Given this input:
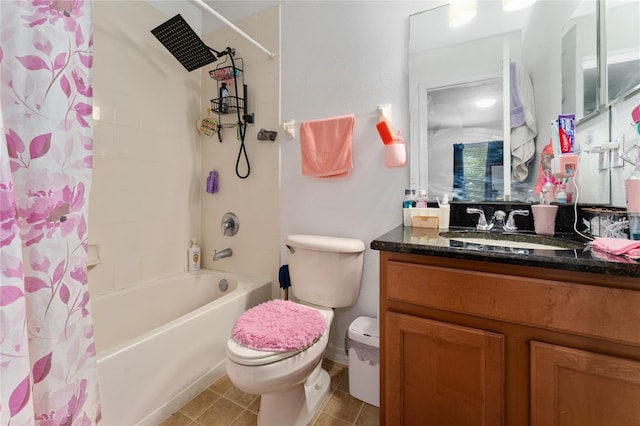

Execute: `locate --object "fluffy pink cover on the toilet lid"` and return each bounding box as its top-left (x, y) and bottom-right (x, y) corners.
top-left (231, 299), bottom-right (327, 352)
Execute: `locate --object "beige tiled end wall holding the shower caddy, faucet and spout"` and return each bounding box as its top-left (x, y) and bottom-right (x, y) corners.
top-left (200, 7), bottom-right (286, 288)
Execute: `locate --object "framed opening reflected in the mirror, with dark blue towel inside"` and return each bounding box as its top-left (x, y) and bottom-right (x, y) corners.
top-left (426, 78), bottom-right (504, 201)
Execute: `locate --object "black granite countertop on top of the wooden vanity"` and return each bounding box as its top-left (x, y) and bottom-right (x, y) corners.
top-left (371, 225), bottom-right (640, 278)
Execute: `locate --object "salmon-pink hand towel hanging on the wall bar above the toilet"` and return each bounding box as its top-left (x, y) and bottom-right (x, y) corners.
top-left (300, 115), bottom-right (355, 177)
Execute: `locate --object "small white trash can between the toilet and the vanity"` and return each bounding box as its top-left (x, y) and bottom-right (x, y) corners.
top-left (345, 317), bottom-right (380, 407)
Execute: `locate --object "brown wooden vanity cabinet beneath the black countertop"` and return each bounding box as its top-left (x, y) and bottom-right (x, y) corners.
top-left (380, 251), bottom-right (640, 426)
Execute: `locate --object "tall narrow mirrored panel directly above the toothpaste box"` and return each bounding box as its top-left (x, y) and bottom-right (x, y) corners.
top-left (561, 0), bottom-right (600, 120)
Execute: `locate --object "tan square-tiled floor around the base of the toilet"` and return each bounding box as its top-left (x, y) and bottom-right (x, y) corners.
top-left (161, 360), bottom-right (380, 426)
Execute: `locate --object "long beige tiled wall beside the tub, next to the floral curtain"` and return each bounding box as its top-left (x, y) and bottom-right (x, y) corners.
top-left (89, 1), bottom-right (201, 296)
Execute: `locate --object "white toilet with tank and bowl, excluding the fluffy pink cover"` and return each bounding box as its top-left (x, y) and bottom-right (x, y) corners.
top-left (226, 235), bottom-right (365, 426)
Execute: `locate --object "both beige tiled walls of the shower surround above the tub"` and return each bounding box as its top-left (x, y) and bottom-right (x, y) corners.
top-left (89, 1), bottom-right (279, 297)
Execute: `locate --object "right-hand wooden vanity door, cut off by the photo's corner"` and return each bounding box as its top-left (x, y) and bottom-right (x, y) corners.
top-left (531, 342), bottom-right (640, 426)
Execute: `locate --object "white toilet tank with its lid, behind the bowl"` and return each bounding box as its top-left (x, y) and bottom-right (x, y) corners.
top-left (285, 235), bottom-right (365, 308)
